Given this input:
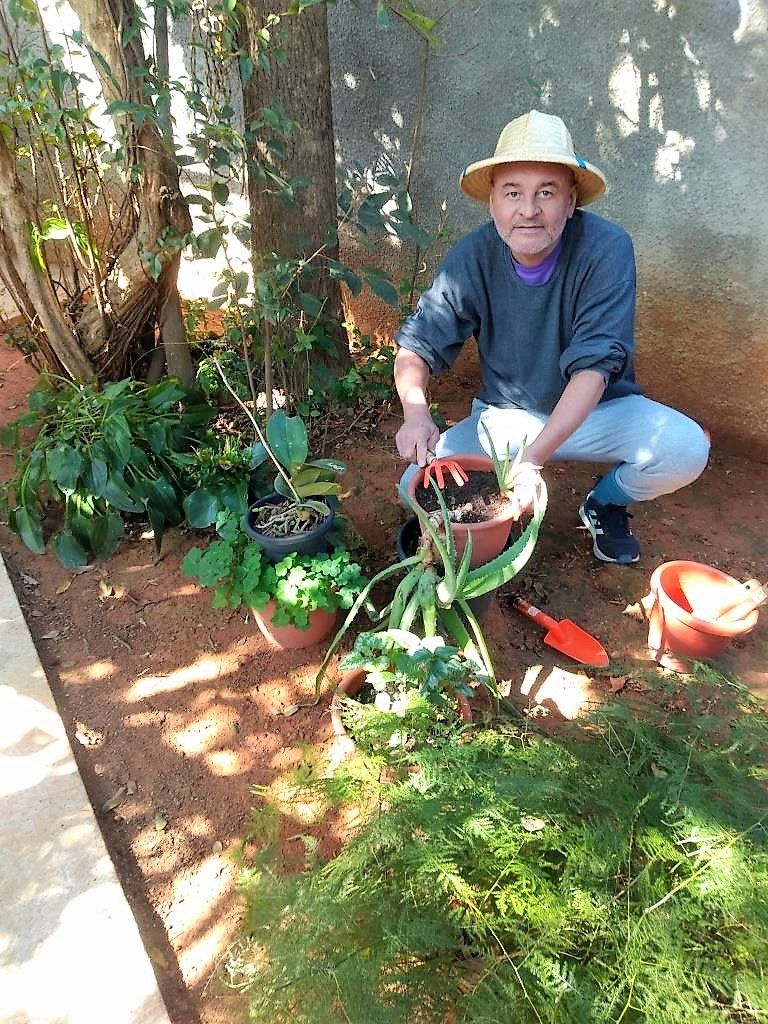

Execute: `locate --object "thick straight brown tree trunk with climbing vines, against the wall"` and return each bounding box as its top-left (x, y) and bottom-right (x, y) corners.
top-left (243, 0), bottom-right (349, 365)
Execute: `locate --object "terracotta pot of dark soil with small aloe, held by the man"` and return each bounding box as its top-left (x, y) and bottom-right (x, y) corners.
top-left (408, 428), bottom-right (539, 568)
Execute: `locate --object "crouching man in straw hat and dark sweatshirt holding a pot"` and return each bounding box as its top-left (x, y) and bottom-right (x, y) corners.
top-left (394, 111), bottom-right (709, 563)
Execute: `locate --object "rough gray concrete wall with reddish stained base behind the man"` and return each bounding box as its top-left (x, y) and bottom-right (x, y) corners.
top-left (330, 0), bottom-right (768, 461)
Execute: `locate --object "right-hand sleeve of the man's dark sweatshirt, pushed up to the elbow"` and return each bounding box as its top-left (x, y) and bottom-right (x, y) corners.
top-left (560, 231), bottom-right (636, 382)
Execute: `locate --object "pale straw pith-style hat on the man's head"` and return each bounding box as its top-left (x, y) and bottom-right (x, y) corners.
top-left (459, 111), bottom-right (606, 206)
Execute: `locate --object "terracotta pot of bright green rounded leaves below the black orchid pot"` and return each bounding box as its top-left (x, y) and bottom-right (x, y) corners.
top-left (181, 517), bottom-right (366, 648)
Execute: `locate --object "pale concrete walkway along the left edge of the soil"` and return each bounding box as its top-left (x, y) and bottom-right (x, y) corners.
top-left (0, 559), bottom-right (169, 1024)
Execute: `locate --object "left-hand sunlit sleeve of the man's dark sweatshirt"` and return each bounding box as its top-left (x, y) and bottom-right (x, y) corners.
top-left (395, 247), bottom-right (479, 374)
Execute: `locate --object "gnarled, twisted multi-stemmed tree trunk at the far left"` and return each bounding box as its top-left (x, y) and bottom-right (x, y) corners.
top-left (0, 0), bottom-right (194, 383)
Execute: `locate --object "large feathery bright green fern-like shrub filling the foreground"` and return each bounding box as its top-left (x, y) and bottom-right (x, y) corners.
top-left (229, 671), bottom-right (768, 1024)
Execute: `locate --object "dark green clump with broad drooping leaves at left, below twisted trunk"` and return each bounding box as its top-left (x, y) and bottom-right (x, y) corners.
top-left (1, 375), bottom-right (213, 566)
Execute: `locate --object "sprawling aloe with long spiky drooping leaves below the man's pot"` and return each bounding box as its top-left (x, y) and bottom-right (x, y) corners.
top-left (315, 476), bottom-right (547, 698)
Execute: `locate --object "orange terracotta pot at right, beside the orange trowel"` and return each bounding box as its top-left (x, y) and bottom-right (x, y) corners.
top-left (648, 561), bottom-right (758, 672)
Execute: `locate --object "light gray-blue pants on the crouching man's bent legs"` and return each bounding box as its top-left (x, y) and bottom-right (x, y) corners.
top-left (402, 394), bottom-right (710, 502)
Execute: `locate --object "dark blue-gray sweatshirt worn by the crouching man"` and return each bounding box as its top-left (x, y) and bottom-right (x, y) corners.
top-left (395, 210), bottom-right (642, 415)
